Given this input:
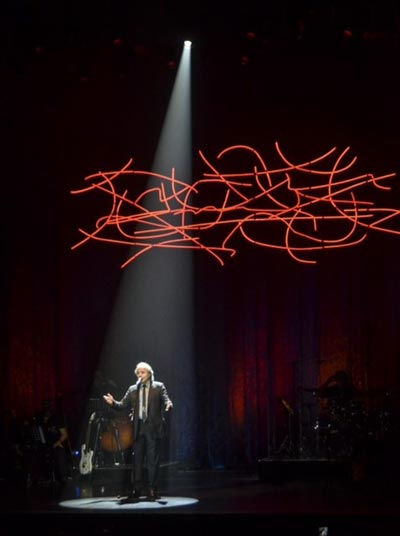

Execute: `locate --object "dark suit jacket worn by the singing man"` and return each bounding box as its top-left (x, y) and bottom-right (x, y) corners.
top-left (113, 381), bottom-right (171, 439)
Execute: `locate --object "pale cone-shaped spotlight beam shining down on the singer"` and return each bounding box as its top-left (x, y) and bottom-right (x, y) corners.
top-left (83, 35), bottom-right (197, 486)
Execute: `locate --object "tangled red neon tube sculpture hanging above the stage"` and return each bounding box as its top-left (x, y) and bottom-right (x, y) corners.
top-left (71, 143), bottom-right (400, 267)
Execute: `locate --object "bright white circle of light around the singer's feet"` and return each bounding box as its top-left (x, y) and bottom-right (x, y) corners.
top-left (59, 497), bottom-right (199, 511)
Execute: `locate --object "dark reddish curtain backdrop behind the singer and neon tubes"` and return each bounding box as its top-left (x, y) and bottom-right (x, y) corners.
top-left (1, 31), bottom-right (400, 467)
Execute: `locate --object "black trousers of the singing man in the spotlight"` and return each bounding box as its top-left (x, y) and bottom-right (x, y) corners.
top-left (132, 422), bottom-right (161, 489)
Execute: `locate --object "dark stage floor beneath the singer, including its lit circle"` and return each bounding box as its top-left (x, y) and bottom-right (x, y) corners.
top-left (0, 460), bottom-right (400, 536)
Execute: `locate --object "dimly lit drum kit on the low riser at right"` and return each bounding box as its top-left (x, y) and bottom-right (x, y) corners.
top-left (277, 385), bottom-right (391, 459)
